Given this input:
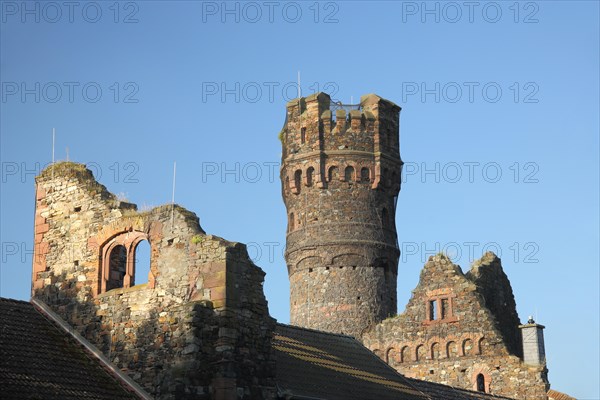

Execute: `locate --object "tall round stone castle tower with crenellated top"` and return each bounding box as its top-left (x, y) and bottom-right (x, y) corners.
top-left (280, 93), bottom-right (402, 337)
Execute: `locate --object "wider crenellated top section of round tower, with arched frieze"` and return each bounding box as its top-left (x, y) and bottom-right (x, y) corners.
top-left (281, 93), bottom-right (402, 193)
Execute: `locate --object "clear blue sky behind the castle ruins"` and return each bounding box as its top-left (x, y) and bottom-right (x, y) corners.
top-left (0, 1), bottom-right (600, 399)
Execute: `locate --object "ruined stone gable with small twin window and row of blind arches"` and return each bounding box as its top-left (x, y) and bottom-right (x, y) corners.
top-left (363, 253), bottom-right (549, 400)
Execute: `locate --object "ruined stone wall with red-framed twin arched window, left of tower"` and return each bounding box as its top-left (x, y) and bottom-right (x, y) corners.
top-left (32, 163), bottom-right (274, 399)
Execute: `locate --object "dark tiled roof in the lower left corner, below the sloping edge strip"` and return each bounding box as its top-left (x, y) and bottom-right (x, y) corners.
top-left (0, 298), bottom-right (137, 400)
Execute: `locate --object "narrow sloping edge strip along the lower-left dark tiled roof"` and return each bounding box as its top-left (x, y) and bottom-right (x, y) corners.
top-left (31, 299), bottom-right (154, 400)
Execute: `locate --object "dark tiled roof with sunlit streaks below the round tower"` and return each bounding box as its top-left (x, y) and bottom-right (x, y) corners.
top-left (273, 324), bottom-right (502, 400)
